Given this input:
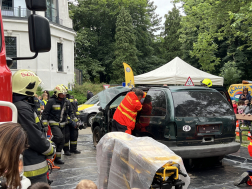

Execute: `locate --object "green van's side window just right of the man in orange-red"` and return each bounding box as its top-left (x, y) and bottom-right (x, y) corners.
top-left (141, 91), bottom-right (166, 116)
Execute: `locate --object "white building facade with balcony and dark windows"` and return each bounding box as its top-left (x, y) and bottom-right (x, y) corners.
top-left (1, 0), bottom-right (76, 90)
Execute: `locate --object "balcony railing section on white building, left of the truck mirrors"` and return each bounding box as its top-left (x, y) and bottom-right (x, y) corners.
top-left (1, 7), bottom-right (31, 18)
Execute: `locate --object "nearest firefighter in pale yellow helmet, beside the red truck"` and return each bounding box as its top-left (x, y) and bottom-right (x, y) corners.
top-left (12, 70), bottom-right (55, 184)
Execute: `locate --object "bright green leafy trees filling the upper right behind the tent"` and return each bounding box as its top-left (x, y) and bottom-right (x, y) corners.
top-left (174, 0), bottom-right (252, 82)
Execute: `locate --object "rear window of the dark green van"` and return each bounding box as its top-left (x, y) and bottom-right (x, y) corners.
top-left (172, 91), bottom-right (234, 117)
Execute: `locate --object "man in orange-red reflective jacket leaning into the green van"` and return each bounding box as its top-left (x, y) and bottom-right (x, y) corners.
top-left (112, 89), bottom-right (146, 134)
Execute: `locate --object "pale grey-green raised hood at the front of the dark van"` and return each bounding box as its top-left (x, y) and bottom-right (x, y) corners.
top-left (98, 86), bottom-right (130, 109)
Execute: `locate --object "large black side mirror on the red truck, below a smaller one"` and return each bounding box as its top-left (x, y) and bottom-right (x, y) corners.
top-left (28, 14), bottom-right (51, 53)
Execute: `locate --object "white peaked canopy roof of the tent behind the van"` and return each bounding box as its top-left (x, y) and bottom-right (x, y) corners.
top-left (134, 57), bottom-right (224, 85)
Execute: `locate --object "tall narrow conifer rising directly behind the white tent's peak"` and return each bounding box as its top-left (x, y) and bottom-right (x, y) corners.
top-left (163, 5), bottom-right (182, 62)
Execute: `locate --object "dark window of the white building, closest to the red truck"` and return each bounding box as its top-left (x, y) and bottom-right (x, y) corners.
top-left (5, 36), bottom-right (17, 69)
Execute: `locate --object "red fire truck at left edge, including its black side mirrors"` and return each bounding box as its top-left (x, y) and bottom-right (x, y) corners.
top-left (0, 0), bottom-right (51, 122)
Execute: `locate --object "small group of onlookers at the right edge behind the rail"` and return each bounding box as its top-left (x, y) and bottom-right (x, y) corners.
top-left (232, 88), bottom-right (252, 127)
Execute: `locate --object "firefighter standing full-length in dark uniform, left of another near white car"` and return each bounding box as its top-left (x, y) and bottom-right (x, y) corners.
top-left (42, 85), bottom-right (78, 164)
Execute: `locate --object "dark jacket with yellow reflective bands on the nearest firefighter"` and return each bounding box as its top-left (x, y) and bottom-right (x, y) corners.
top-left (14, 101), bottom-right (54, 177)
